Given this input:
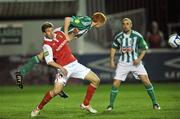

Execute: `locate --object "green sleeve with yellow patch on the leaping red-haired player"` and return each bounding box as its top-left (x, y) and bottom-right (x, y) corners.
top-left (70, 16), bottom-right (92, 27)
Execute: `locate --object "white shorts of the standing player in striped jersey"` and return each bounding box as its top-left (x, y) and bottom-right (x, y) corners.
top-left (114, 62), bottom-right (147, 81)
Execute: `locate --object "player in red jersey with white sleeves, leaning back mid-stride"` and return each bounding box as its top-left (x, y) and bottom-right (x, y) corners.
top-left (31, 19), bottom-right (106, 117)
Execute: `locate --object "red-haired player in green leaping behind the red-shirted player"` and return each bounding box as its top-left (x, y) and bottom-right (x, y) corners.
top-left (15, 12), bottom-right (107, 93)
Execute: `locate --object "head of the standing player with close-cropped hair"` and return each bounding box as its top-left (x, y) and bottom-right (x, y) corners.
top-left (121, 18), bottom-right (132, 33)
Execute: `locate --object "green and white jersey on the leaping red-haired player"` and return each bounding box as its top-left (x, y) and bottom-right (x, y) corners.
top-left (61, 16), bottom-right (92, 37)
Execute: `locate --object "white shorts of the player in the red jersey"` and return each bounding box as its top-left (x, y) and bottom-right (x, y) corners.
top-left (55, 60), bottom-right (91, 86)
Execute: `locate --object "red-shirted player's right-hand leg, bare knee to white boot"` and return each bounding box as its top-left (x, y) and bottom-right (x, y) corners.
top-left (81, 71), bottom-right (100, 113)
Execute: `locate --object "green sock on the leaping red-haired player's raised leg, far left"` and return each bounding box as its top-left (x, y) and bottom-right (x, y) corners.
top-left (18, 56), bottom-right (40, 76)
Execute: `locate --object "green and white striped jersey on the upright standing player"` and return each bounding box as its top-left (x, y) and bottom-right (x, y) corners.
top-left (112, 30), bottom-right (148, 63)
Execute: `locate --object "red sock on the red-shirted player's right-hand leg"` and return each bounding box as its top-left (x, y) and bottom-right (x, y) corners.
top-left (83, 84), bottom-right (96, 106)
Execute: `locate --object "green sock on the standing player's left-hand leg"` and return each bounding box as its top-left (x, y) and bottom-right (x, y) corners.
top-left (110, 86), bottom-right (118, 107)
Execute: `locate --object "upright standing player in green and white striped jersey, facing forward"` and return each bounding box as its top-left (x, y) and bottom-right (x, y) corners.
top-left (107, 18), bottom-right (160, 111)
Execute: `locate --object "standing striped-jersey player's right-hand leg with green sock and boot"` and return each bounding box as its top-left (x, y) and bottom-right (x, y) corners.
top-left (139, 75), bottom-right (160, 110)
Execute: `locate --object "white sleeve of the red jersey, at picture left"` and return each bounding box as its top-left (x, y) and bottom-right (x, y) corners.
top-left (43, 45), bottom-right (54, 64)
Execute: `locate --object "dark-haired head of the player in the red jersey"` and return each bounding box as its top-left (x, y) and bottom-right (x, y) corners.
top-left (41, 22), bottom-right (54, 39)
